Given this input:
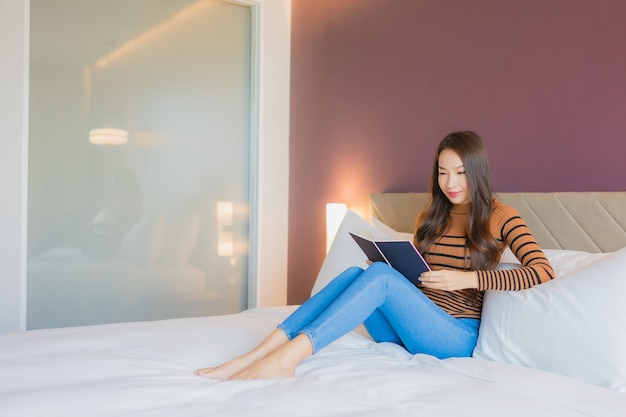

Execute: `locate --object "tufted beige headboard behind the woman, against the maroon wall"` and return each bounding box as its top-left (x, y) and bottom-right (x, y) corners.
top-left (370, 191), bottom-right (626, 252)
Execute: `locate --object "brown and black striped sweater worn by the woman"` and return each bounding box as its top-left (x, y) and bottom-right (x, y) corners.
top-left (420, 201), bottom-right (555, 319)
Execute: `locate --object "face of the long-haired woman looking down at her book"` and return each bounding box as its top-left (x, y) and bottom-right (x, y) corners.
top-left (438, 149), bottom-right (470, 204)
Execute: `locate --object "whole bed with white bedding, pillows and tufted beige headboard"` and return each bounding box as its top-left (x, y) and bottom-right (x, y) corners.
top-left (0, 192), bottom-right (626, 417)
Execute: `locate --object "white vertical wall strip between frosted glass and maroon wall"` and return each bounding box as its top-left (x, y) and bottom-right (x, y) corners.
top-left (250, 0), bottom-right (291, 306)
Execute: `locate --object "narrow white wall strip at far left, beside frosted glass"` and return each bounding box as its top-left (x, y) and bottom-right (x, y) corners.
top-left (0, 0), bottom-right (28, 332)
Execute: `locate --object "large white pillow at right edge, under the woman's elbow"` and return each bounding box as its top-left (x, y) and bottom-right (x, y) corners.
top-left (473, 248), bottom-right (626, 392)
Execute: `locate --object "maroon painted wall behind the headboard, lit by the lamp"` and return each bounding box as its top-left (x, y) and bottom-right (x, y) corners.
top-left (288, 0), bottom-right (626, 303)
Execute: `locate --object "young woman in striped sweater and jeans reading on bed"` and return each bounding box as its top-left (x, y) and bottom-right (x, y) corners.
top-left (196, 131), bottom-right (554, 380)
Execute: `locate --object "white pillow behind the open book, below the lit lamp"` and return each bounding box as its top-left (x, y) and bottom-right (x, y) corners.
top-left (311, 210), bottom-right (397, 295)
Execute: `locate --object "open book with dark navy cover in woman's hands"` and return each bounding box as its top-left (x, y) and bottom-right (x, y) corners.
top-left (349, 232), bottom-right (430, 285)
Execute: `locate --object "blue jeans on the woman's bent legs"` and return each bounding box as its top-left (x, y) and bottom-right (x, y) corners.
top-left (278, 262), bottom-right (479, 359)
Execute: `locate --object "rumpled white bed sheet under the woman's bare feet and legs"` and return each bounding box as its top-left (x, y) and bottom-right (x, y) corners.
top-left (0, 307), bottom-right (626, 417)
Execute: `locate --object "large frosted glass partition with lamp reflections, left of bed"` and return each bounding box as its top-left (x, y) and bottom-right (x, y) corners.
top-left (27, 0), bottom-right (252, 329)
